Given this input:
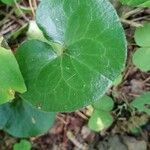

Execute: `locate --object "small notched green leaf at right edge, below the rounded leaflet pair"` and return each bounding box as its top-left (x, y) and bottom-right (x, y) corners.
top-left (131, 92), bottom-right (150, 115)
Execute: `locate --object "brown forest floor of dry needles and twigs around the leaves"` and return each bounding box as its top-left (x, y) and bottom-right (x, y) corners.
top-left (0, 0), bottom-right (150, 150)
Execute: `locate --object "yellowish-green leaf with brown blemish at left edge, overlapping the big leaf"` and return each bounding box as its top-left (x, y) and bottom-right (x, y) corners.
top-left (0, 47), bottom-right (26, 104)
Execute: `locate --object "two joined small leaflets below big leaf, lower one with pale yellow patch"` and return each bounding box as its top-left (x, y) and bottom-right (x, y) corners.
top-left (88, 96), bottom-right (114, 132)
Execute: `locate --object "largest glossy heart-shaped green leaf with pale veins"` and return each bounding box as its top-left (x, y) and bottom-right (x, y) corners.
top-left (16, 0), bottom-right (126, 111)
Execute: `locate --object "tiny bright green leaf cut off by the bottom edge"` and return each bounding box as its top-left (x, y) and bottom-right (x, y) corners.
top-left (13, 140), bottom-right (31, 150)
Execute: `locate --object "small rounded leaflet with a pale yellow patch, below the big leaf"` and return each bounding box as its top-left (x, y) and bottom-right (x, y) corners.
top-left (88, 110), bottom-right (113, 132)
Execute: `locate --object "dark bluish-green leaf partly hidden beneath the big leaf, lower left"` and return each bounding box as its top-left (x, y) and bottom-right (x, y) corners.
top-left (0, 99), bottom-right (55, 137)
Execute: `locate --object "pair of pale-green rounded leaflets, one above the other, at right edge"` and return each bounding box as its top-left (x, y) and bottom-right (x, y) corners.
top-left (133, 23), bottom-right (150, 71)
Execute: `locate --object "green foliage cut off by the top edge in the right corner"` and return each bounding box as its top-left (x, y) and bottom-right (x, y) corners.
top-left (120, 0), bottom-right (150, 7)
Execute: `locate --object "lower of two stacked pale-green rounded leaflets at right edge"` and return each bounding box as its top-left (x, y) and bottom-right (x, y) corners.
top-left (133, 47), bottom-right (150, 71)
